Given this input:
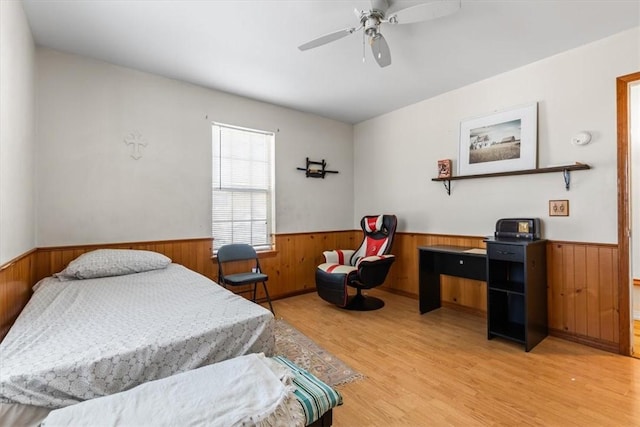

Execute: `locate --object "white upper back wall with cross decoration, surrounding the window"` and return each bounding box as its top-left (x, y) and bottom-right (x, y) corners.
top-left (37, 49), bottom-right (353, 246)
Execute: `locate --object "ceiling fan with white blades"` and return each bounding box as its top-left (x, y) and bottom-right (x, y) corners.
top-left (298, 0), bottom-right (460, 67)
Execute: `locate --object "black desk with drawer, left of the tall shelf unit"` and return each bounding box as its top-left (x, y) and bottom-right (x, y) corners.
top-left (418, 246), bottom-right (487, 314)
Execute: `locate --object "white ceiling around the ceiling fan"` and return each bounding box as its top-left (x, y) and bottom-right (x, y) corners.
top-left (24, 0), bottom-right (640, 123)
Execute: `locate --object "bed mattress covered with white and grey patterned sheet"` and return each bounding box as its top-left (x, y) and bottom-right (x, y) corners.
top-left (0, 264), bottom-right (275, 408)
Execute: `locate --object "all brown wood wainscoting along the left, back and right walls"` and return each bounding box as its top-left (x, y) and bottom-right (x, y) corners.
top-left (0, 230), bottom-right (620, 352)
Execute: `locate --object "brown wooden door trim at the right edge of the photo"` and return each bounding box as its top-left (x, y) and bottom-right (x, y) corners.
top-left (616, 72), bottom-right (640, 356)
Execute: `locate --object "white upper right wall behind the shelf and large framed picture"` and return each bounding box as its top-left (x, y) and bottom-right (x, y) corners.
top-left (354, 28), bottom-right (640, 243)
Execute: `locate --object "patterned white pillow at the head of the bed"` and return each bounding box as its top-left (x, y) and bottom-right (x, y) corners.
top-left (55, 249), bottom-right (171, 280)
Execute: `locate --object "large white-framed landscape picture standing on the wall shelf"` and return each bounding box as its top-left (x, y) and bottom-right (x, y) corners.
top-left (458, 102), bottom-right (538, 175)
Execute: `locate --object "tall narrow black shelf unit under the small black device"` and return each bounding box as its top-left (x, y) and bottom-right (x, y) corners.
top-left (487, 240), bottom-right (548, 351)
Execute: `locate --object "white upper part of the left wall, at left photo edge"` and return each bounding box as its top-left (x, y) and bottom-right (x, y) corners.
top-left (0, 1), bottom-right (35, 265)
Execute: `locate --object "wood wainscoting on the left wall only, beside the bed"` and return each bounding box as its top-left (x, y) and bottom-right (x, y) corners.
top-left (0, 250), bottom-right (35, 341)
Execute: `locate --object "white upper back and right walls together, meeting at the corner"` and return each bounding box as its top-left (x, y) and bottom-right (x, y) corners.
top-left (27, 28), bottom-right (640, 246)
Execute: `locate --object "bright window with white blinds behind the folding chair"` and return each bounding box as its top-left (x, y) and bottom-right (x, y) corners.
top-left (211, 123), bottom-right (274, 252)
